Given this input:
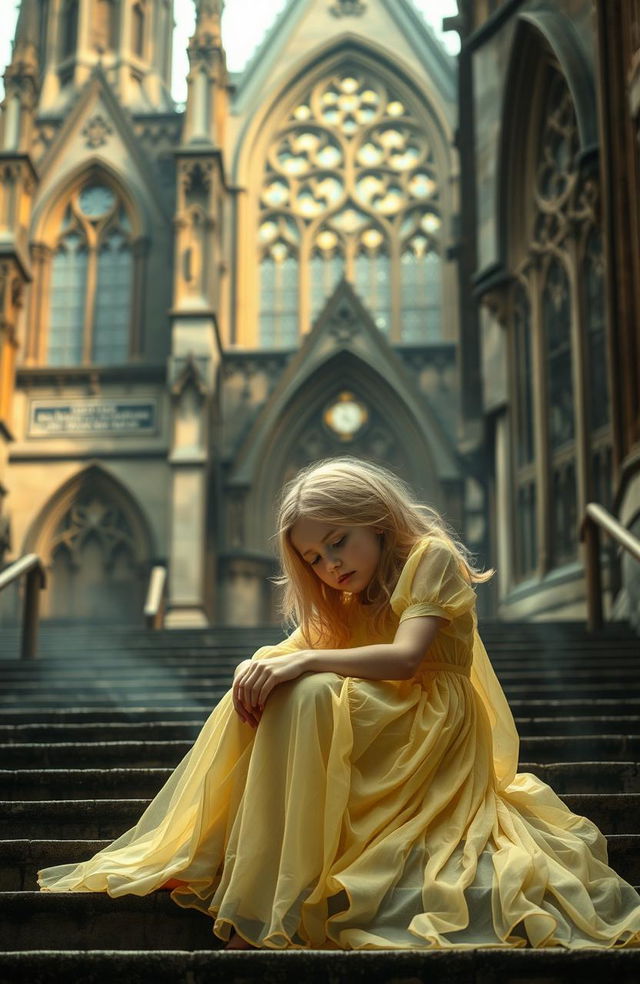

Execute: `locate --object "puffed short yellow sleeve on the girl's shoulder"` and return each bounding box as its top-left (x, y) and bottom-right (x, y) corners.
top-left (390, 537), bottom-right (476, 622)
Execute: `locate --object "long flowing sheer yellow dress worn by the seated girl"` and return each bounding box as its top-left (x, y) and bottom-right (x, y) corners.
top-left (39, 536), bottom-right (640, 949)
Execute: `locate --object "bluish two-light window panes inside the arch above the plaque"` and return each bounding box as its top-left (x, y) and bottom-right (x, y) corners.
top-left (47, 180), bottom-right (134, 365)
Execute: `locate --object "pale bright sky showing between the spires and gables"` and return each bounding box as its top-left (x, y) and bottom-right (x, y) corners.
top-left (0, 0), bottom-right (460, 102)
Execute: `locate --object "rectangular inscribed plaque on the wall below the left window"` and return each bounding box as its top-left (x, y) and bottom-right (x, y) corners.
top-left (29, 397), bottom-right (158, 437)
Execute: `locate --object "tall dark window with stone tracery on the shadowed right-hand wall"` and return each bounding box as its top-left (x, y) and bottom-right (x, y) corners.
top-left (511, 66), bottom-right (611, 579)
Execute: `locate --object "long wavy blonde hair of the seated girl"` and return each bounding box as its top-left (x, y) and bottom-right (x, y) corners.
top-left (273, 455), bottom-right (493, 648)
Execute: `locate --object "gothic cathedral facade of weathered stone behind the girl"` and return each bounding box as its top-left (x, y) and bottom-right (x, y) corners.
top-left (0, 0), bottom-right (640, 628)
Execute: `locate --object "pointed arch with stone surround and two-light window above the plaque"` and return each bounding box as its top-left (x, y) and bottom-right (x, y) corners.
top-left (28, 160), bottom-right (142, 366)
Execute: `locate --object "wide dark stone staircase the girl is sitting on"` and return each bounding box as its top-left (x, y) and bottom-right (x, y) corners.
top-left (0, 623), bottom-right (640, 984)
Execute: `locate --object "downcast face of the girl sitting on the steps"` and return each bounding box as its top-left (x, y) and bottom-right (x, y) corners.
top-left (291, 518), bottom-right (382, 594)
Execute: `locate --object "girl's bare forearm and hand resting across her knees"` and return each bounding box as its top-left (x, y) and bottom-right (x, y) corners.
top-left (233, 615), bottom-right (447, 724)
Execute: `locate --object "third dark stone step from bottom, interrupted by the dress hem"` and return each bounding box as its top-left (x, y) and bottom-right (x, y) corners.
top-left (5, 834), bottom-right (640, 896)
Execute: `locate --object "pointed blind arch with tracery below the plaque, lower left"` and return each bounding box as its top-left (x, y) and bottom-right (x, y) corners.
top-left (25, 464), bottom-right (154, 623)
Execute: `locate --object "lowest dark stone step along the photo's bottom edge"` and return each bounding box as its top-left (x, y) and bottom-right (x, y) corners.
top-left (2, 944), bottom-right (640, 984)
